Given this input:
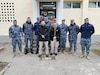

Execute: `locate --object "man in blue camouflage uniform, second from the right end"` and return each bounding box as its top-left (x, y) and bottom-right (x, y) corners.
top-left (68, 19), bottom-right (79, 55)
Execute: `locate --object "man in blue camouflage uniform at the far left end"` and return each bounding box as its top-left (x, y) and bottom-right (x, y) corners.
top-left (9, 20), bottom-right (23, 56)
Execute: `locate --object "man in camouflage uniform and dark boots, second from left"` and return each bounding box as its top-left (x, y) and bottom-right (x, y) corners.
top-left (23, 17), bottom-right (34, 54)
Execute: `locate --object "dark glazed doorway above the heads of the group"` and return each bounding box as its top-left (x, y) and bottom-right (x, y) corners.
top-left (39, 2), bottom-right (56, 18)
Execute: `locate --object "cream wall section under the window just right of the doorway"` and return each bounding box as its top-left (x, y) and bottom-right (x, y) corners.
top-left (63, 9), bottom-right (82, 25)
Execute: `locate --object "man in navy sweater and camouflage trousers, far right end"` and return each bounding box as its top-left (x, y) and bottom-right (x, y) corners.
top-left (80, 18), bottom-right (95, 59)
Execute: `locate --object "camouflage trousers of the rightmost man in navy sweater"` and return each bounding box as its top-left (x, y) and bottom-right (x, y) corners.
top-left (81, 38), bottom-right (91, 53)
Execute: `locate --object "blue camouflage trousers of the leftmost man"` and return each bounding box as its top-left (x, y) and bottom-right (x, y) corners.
top-left (12, 38), bottom-right (22, 52)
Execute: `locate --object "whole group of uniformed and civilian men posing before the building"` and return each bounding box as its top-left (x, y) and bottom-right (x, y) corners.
top-left (9, 16), bottom-right (95, 59)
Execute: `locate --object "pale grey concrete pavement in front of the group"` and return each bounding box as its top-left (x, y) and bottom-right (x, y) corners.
top-left (0, 44), bottom-right (100, 75)
